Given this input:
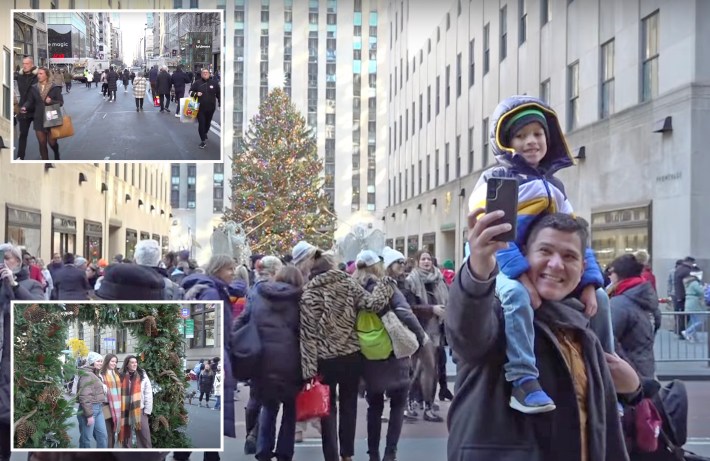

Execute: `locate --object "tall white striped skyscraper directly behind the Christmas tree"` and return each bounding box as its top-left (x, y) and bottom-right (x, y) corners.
top-left (171, 0), bottom-right (389, 261)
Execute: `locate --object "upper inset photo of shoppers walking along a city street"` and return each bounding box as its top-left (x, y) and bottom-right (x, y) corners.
top-left (11, 10), bottom-right (224, 163)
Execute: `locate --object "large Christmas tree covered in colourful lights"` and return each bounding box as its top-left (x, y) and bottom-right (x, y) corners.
top-left (228, 88), bottom-right (336, 255)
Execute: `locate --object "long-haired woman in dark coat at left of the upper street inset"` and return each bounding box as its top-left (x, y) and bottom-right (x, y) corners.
top-left (20, 67), bottom-right (64, 162)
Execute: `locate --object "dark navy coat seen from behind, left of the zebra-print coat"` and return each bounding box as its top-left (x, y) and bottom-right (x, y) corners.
top-left (232, 282), bottom-right (303, 400)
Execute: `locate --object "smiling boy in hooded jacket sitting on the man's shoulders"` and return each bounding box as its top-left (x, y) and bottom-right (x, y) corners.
top-left (469, 96), bottom-right (614, 414)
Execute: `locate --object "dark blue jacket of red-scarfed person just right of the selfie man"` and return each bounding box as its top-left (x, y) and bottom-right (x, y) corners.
top-left (609, 278), bottom-right (661, 378)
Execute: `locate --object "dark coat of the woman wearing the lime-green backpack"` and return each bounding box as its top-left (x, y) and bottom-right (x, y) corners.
top-left (363, 277), bottom-right (425, 394)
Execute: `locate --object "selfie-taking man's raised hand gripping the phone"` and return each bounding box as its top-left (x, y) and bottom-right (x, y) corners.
top-left (467, 208), bottom-right (513, 280)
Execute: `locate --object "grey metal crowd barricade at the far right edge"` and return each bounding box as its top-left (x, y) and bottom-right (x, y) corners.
top-left (653, 309), bottom-right (710, 367)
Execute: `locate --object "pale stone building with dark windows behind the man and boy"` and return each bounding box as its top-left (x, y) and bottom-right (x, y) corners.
top-left (382, 0), bottom-right (710, 293)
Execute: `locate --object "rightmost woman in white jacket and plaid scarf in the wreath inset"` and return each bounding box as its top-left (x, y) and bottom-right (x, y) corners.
top-left (118, 355), bottom-right (153, 448)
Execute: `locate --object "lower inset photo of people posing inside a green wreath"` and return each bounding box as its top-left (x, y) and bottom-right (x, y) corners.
top-left (11, 302), bottom-right (224, 452)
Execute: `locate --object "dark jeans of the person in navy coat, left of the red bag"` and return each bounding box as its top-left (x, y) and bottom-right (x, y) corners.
top-left (256, 397), bottom-right (296, 459)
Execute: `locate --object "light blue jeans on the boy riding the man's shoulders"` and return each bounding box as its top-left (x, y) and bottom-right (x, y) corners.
top-left (496, 272), bottom-right (614, 382)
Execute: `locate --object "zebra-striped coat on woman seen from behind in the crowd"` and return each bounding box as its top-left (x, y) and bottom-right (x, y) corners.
top-left (300, 269), bottom-right (395, 380)
